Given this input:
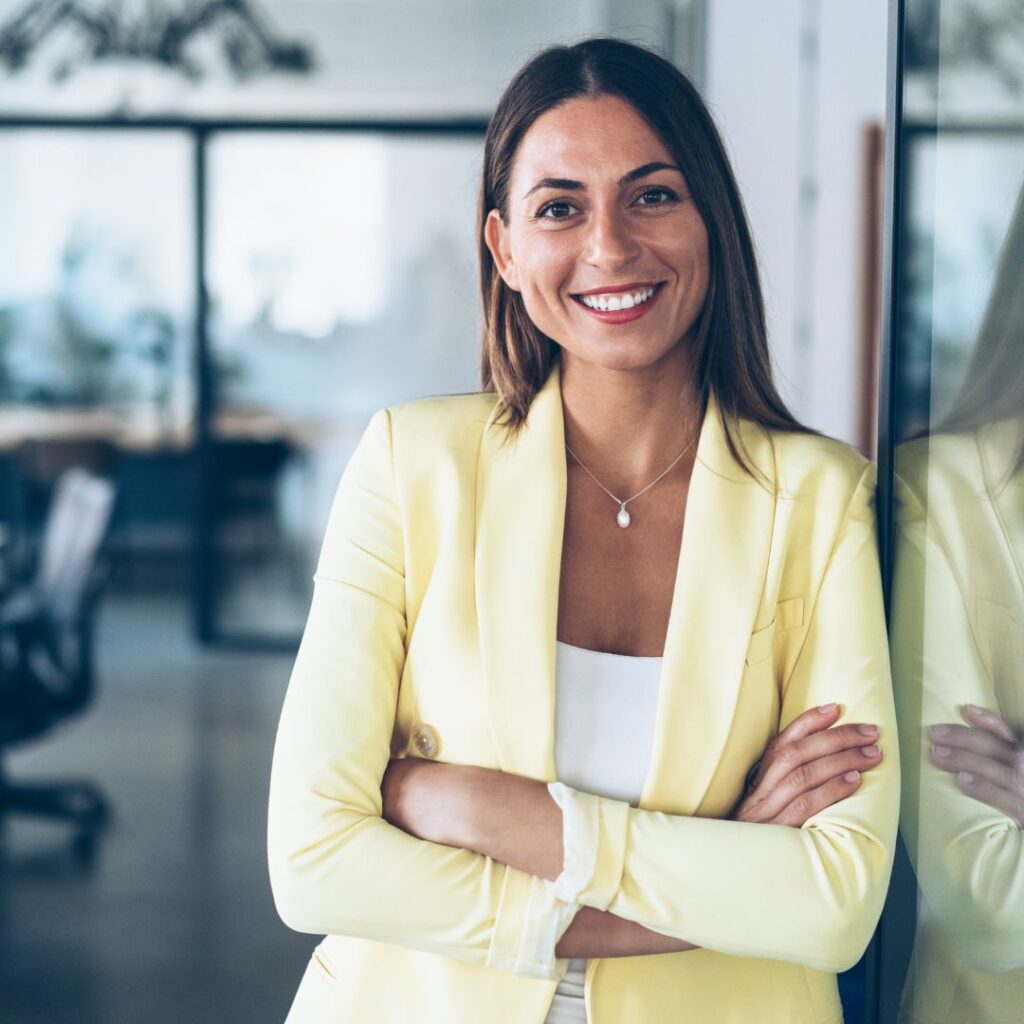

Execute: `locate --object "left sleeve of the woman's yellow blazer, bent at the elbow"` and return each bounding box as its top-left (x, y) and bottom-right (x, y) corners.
top-left (267, 410), bottom-right (579, 979)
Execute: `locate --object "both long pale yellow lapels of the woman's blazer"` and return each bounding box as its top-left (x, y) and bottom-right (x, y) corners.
top-left (474, 362), bottom-right (775, 814)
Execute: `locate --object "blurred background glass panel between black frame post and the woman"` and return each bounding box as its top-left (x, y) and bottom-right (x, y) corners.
top-left (209, 132), bottom-right (480, 640)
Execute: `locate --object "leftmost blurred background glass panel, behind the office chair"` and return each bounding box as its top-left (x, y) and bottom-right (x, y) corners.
top-left (0, 129), bottom-right (195, 584)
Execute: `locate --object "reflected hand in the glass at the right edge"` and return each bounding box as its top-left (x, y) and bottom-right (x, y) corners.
top-left (928, 705), bottom-right (1024, 827)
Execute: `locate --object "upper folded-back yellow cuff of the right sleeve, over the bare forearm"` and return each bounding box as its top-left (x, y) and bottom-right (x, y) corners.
top-left (544, 782), bottom-right (631, 910)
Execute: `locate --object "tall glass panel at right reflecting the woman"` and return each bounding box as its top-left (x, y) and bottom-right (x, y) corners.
top-left (885, 0), bottom-right (1024, 1024)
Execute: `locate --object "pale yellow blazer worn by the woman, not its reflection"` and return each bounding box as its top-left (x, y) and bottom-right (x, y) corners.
top-left (269, 365), bottom-right (899, 1024)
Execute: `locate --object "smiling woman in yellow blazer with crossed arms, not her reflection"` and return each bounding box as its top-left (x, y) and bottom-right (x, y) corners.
top-left (269, 39), bottom-right (898, 1024)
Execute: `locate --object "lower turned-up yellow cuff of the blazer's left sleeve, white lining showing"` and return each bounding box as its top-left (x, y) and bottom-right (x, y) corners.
top-left (486, 867), bottom-right (580, 981)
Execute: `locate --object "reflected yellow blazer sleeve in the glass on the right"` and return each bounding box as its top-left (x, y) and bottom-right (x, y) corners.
top-left (893, 478), bottom-right (1024, 972)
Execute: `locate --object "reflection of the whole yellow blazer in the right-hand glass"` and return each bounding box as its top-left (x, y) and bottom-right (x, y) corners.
top-left (892, 420), bottom-right (1024, 1024)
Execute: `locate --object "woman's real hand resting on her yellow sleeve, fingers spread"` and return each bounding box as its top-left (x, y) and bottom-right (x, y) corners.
top-left (730, 705), bottom-right (882, 828)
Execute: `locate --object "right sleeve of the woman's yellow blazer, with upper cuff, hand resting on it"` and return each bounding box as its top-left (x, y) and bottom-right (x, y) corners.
top-left (546, 464), bottom-right (899, 972)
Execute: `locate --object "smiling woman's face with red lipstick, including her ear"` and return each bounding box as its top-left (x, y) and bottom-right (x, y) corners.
top-left (484, 95), bottom-right (709, 370)
